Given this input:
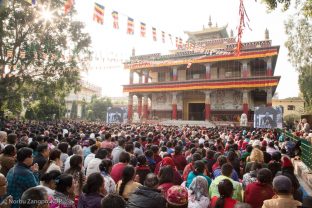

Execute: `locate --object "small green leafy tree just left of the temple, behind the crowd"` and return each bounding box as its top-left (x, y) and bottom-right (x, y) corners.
top-left (87, 96), bottom-right (112, 121)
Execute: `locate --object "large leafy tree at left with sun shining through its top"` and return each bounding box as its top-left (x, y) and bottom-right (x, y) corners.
top-left (0, 0), bottom-right (91, 114)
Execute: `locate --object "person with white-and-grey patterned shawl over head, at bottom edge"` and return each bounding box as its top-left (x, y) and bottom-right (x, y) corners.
top-left (188, 176), bottom-right (209, 208)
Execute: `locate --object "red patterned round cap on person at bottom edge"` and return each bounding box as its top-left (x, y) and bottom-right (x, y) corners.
top-left (166, 186), bottom-right (188, 208)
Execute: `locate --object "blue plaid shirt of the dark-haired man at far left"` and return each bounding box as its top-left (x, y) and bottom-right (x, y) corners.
top-left (7, 163), bottom-right (39, 208)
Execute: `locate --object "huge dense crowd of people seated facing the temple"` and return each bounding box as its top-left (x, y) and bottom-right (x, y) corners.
top-left (0, 121), bottom-right (312, 208)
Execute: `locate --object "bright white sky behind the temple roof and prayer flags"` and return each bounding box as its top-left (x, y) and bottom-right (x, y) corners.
top-left (75, 0), bottom-right (299, 98)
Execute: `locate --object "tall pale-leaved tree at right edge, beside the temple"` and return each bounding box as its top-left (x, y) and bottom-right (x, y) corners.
top-left (264, 0), bottom-right (312, 110)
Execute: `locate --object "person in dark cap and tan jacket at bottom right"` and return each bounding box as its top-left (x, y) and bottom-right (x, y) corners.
top-left (262, 175), bottom-right (301, 208)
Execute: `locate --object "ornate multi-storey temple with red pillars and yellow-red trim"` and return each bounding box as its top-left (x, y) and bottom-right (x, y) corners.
top-left (123, 25), bottom-right (280, 121)
